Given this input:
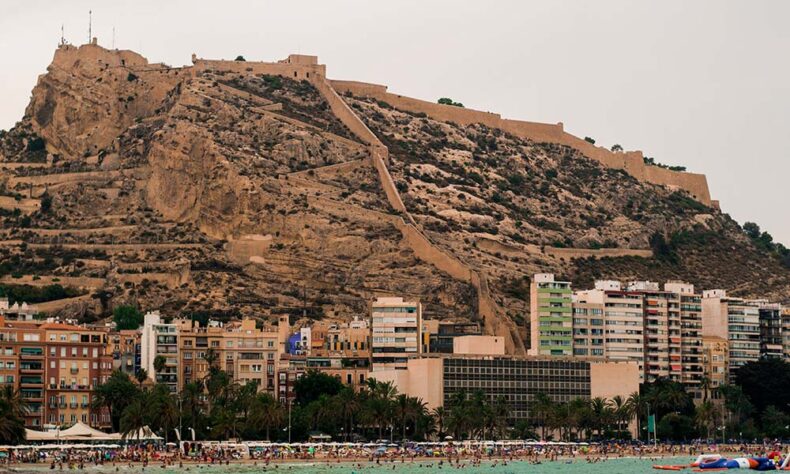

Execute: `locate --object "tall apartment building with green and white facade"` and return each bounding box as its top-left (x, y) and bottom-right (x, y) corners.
top-left (528, 273), bottom-right (573, 357)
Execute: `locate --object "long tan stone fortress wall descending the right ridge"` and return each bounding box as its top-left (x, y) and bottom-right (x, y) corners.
top-left (331, 80), bottom-right (716, 206)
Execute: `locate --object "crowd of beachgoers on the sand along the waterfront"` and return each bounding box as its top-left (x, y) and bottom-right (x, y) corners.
top-left (0, 441), bottom-right (781, 471)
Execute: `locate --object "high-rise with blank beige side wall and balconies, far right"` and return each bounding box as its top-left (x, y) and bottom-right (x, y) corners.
top-left (702, 290), bottom-right (760, 378)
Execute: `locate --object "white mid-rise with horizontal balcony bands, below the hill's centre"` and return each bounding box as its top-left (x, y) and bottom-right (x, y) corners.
top-left (370, 297), bottom-right (422, 370)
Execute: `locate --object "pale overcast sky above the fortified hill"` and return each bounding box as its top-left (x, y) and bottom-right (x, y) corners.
top-left (0, 0), bottom-right (790, 246)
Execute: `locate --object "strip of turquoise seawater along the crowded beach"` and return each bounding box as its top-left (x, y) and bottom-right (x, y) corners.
top-left (14, 457), bottom-right (691, 474)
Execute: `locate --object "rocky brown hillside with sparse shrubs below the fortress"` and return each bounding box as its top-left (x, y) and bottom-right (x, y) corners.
top-left (0, 46), bottom-right (790, 330)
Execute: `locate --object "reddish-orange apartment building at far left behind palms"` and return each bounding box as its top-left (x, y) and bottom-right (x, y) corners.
top-left (0, 316), bottom-right (112, 429)
